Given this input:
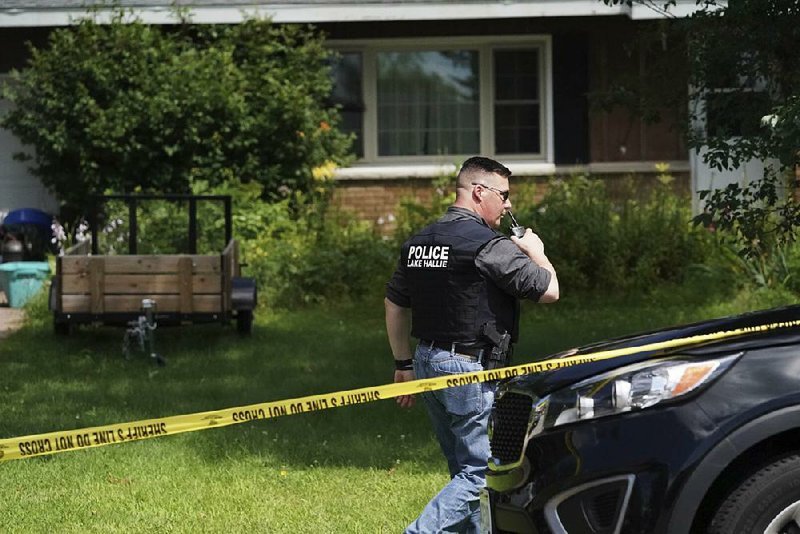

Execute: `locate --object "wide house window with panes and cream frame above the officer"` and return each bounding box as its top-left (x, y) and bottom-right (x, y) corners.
top-left (326, 37), bottom-right (552, 163)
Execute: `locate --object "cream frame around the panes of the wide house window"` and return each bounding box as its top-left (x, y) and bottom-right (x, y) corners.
top-left (328, 35), bottom-right (554, 165)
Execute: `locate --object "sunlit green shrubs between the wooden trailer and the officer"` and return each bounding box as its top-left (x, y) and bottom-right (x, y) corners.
top-left (195, 178), bottom-right (393, 307)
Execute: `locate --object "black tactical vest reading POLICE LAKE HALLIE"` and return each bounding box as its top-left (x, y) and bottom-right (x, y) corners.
top-left (401, 217), bottom-right (518, 343)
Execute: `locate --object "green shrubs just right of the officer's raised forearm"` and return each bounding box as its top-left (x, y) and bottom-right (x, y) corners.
top-left (510, 170), bottom-right (708, 292)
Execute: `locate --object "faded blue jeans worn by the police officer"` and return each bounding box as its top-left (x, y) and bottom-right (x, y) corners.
top-left (406, 345), bottom-right (494, 534)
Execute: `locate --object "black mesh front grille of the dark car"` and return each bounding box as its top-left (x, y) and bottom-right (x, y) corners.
top-left (490, 391), bottom-right (533, 465)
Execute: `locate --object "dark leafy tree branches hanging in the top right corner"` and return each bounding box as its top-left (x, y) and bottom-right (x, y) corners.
top-left (592, 0), bottom-right (800, 174)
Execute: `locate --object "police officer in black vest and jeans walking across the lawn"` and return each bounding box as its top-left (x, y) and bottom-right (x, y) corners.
top-left (385, 157), bottom-right (559, 534)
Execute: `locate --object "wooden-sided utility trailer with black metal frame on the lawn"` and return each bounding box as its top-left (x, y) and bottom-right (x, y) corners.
top-left (50, 195), bottom-right (257, 334)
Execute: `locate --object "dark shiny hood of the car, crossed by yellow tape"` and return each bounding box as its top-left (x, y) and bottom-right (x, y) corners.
top-left (498, 305), bottom-right (800, 398)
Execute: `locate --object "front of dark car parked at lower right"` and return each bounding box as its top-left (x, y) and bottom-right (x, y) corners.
top-left (481, 306), bottom-right (800, 534)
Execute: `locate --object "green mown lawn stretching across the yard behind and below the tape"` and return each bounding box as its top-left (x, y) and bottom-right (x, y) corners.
top-left (0, 283), bottom-right (793, 533)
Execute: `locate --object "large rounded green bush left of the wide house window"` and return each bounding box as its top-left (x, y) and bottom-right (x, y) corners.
top-left (0, 12), bottom-right (350, 216)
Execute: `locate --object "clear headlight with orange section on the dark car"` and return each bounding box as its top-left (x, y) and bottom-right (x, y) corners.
top-left (532, 353), bottom-right (741, 434)
